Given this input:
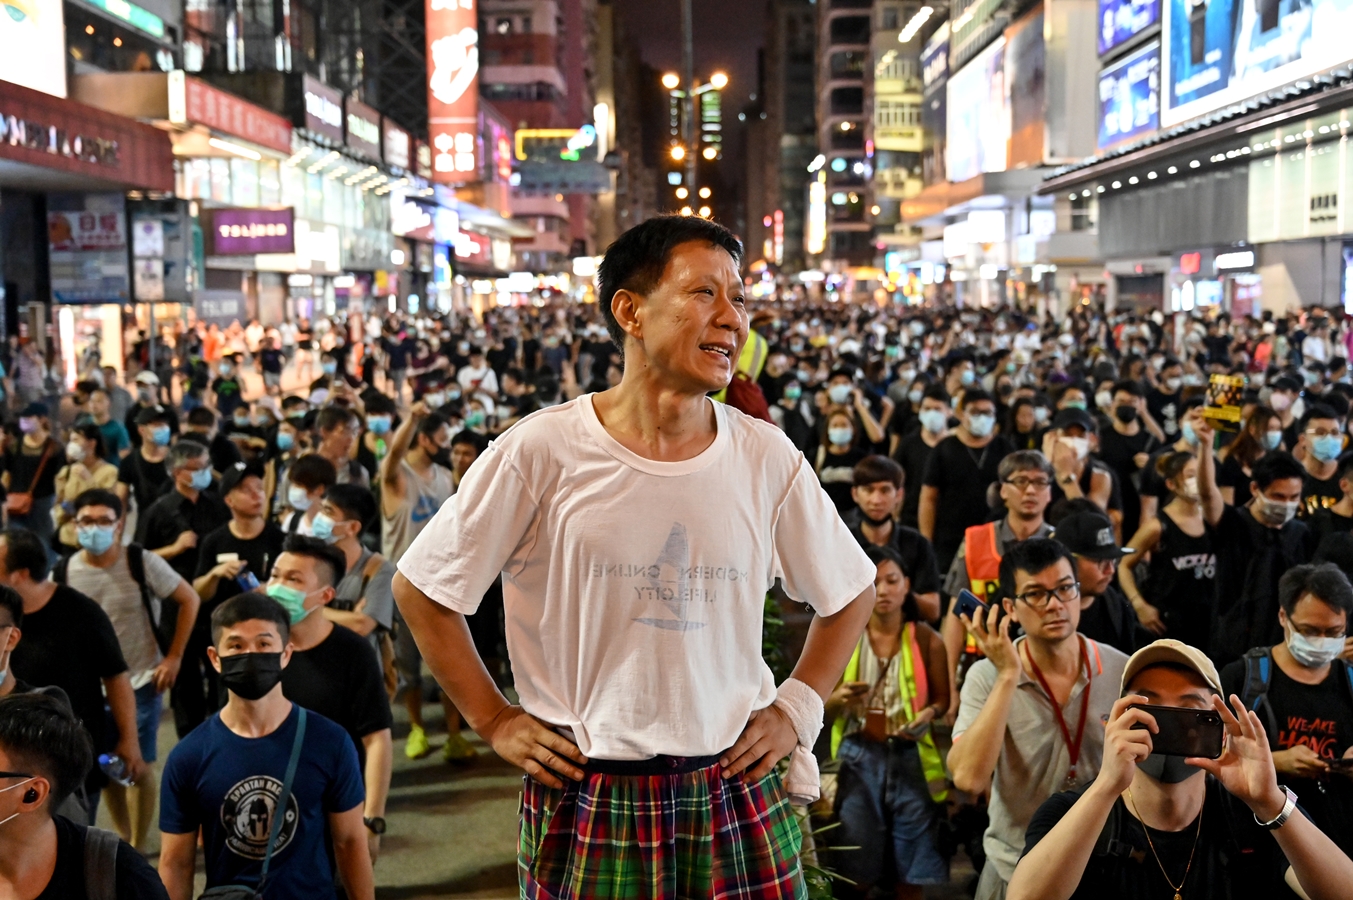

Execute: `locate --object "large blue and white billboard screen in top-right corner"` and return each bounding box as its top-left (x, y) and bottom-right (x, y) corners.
top-left (1161, 0), bottom-right (1353, 127)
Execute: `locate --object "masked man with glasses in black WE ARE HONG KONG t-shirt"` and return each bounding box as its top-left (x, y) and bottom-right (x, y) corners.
top-left (1222, 563), bottom-right (1353, 853)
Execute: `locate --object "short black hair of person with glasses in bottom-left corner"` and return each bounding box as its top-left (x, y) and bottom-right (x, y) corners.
top-left (0, 690), bottom-right (93, 815)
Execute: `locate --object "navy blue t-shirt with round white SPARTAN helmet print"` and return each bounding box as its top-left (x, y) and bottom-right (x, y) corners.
top-left (160, 705), bottom-right (365, 900)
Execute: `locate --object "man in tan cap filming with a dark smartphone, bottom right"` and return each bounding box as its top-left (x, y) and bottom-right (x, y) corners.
top-left (1007, 640), bottom-right (1353, 900)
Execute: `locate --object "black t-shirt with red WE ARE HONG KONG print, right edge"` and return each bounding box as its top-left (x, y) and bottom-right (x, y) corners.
top-left (1222, 660), bottom-right (1353, 853)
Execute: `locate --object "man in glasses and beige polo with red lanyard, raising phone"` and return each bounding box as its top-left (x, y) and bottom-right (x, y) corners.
top-left (948, 539), bottom-right (1127, 900)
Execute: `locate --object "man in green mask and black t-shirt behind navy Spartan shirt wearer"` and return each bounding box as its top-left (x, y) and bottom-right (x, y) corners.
top-left (267, 535), bottom-right (394, 859)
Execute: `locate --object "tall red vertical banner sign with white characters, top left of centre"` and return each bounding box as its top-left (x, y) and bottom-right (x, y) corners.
top-left (428, 0), bottom-right (479, 184)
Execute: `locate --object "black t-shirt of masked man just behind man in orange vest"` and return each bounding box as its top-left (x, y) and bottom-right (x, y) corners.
top-left (923, 434), bottom-right (1012, 567)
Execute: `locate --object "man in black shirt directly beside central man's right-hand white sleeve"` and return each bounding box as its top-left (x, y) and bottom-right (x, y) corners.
top-left (842, 456), bottom-right (939, 621)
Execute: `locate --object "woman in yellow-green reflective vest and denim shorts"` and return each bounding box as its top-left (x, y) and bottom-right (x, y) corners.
top-left (827, 545), bottom-right (948, 900)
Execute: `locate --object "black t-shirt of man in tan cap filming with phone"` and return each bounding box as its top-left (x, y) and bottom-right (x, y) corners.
top-left (1024, 775), bottom-right (1292, 900)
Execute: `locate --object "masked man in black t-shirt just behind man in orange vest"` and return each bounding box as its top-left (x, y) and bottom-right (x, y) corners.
top-left (917, 388), bottom-right (1013, 571)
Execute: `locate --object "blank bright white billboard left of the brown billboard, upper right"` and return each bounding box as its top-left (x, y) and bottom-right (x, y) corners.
top-left (944, 37), bottom-right (1011, 181)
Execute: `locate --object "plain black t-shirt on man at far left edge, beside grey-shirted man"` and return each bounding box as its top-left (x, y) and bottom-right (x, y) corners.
top-left (9, 585), bottom-right (127, 752)
